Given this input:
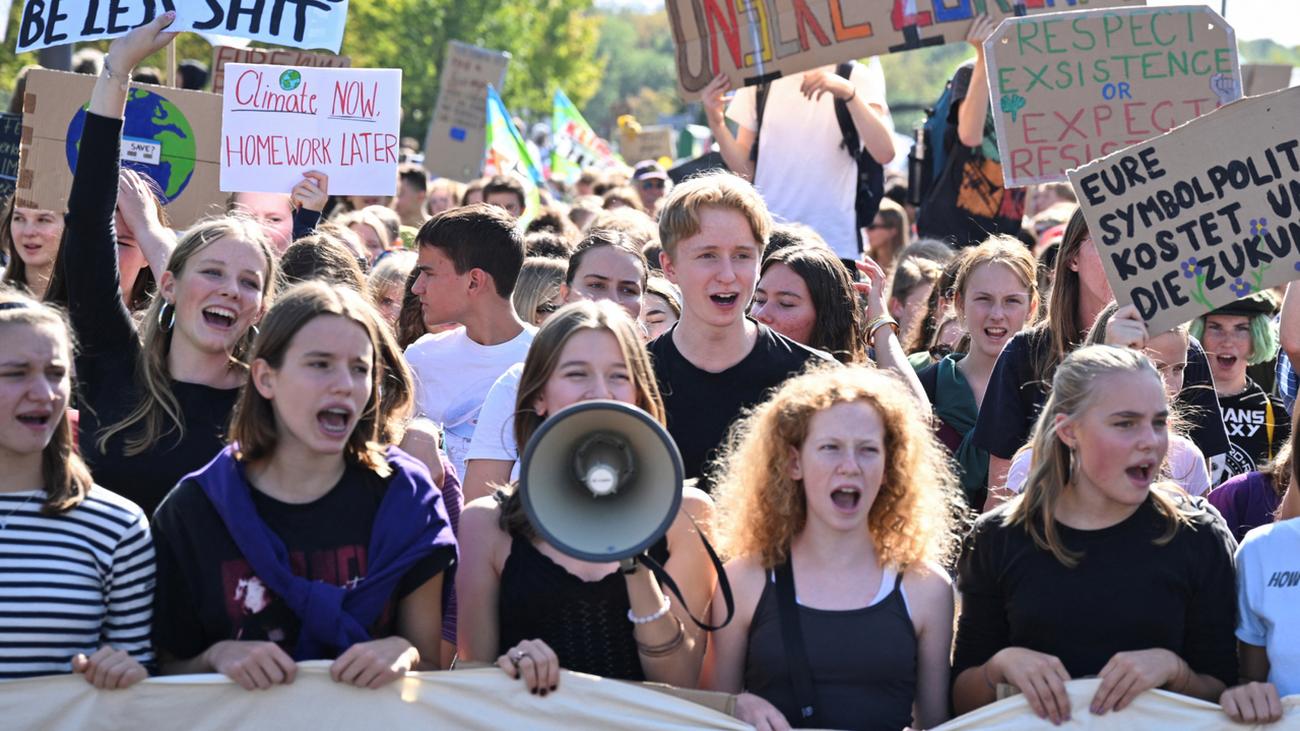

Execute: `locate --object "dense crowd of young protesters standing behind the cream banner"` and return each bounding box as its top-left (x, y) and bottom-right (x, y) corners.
top-left (0, 13), bottom-right (1300, 731)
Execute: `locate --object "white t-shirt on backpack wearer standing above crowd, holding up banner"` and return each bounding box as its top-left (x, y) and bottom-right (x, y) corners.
top-left (727, 57), bottom-right (893, 259)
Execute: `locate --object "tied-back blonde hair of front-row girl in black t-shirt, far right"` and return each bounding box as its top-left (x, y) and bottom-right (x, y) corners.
top-left (1002, 345), bottom-right (1203, 568)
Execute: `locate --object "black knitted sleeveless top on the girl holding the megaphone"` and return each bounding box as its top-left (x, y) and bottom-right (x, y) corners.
top-left (497, 535), bottom-right (668, 680)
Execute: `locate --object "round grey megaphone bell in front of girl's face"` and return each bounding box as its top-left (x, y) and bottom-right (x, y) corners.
top-left (519, 401), bottom-right (685, 563)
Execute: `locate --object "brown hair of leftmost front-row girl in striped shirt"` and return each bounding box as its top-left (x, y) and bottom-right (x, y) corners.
top-left (0, 289), bottom-right (94, 515)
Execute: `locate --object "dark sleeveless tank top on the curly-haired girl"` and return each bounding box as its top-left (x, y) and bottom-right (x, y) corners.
top-left (745, 564), bottom-right (917, 731)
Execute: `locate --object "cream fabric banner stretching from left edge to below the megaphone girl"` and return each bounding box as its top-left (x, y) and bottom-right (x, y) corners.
top-left (0, 662), bottom-right (749, 731)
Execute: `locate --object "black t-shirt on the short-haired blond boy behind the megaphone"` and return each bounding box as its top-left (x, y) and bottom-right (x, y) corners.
top-left (649, 323), bottom-right (835, 488)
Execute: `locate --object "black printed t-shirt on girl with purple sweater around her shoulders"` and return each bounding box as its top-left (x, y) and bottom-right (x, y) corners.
top-left (153, 464), bottom-right (451, 659)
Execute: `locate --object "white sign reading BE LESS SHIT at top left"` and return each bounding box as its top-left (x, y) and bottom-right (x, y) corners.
top-left (16, 0), bottom-right (347, 53)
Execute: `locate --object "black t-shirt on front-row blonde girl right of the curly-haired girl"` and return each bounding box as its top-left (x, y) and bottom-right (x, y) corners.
top-left (953, 497), bottom-right (1238, 685)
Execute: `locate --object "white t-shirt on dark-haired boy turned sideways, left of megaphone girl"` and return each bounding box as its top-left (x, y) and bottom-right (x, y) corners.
top-left (406, 326), bottom-right (537, 477)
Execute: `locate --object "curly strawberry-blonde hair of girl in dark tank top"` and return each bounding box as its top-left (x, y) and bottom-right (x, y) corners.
top-left (714, 366), bottom-right (967, 568)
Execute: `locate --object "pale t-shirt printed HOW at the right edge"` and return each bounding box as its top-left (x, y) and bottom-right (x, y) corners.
top-left (1236, 518), bottom-right (1300, 696)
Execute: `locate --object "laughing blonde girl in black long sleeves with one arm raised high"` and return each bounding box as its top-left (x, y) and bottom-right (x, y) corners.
top-left (64, 22), bottom-right (276, 514)
